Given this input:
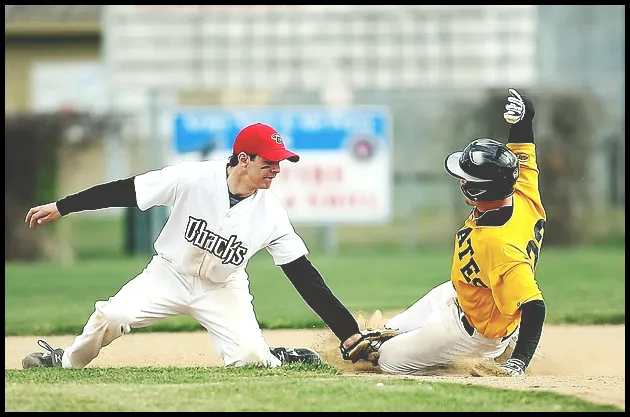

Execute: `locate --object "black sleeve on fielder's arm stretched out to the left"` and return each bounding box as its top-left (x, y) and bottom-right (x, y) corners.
top-left (57, 177), bottom-right (138, 216)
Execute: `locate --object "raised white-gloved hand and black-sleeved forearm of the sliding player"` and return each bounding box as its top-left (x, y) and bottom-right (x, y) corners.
top-left (503, 88), bottom-right (536, 143)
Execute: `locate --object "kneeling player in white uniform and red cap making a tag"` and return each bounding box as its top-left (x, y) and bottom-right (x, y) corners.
top-left (22, 123), bottom-right (368, 368)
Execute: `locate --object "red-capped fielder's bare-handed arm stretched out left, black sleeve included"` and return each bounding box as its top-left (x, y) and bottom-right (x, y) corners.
top-left (24, 177), bottom-right (138, 228)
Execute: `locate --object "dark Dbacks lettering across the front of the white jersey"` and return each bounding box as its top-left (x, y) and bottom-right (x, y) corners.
top-left (184, 216), bottom-right (247, 266)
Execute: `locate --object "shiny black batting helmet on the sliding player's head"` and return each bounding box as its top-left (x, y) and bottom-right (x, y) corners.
top-left (444, 138), bottom-right (519, 201)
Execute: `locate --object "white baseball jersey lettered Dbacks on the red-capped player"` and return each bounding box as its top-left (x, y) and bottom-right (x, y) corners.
top-left (135, 160), bottom-right (308, 282)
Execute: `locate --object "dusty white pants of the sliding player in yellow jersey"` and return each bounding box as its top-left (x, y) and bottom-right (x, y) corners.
top-left (378, 280), bottom-right (509, 375)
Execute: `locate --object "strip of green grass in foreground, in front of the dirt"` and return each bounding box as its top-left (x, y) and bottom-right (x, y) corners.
top-left (4, 365), bottom-right (622, 412)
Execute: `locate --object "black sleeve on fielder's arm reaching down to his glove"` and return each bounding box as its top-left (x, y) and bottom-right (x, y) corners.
top-left (280, 256), bottom-right (359, 342)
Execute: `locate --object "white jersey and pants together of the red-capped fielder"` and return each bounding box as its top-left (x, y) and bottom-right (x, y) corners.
top-left (62, 161), bottom-right (308, 368)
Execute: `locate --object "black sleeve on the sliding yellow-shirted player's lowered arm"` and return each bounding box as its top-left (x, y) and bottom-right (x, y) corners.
top-left (511, 300), bottom-right (546, 366)
